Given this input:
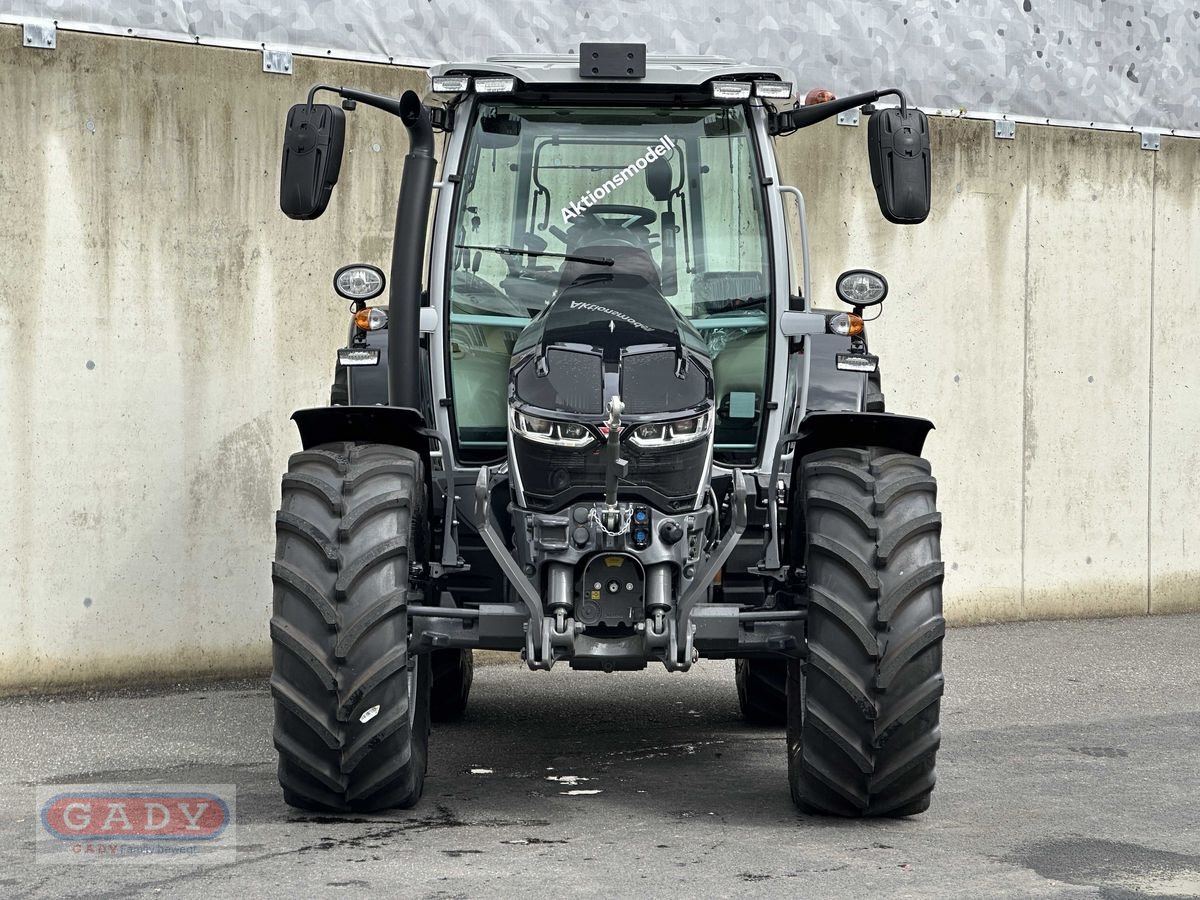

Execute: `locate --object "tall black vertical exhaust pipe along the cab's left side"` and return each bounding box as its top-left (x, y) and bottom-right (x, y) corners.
top-left (388, 91), bottom-right (438, 409)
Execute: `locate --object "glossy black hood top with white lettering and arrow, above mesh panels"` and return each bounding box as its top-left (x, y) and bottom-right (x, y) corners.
top-left (512, 272), bottom-right (708, 364)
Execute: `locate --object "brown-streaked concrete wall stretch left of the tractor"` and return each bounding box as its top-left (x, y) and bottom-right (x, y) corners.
top-left (0, 28), bottom-right (424, 686)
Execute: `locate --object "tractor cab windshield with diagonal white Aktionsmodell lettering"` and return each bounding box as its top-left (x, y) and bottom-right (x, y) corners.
top-left (446, 102), bottom-right (770, 461)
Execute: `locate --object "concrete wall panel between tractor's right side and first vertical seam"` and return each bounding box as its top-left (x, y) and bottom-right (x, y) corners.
top-left (780, 120), bottom-right (1028, 622)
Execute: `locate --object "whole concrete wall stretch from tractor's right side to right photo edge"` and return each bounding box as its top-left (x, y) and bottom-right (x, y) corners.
top-left (781, 119), bottom-right (1200, 624)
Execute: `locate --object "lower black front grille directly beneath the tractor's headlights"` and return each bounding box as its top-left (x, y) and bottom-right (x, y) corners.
top-left (512, 434), bottom-right (708, 512)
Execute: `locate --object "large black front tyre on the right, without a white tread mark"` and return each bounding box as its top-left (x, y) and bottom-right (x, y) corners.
top-left (787, 448), bottom-right (946, 816)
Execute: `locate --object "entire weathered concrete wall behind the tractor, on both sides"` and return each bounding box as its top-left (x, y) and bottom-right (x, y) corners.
top-left (0, 26), bottom-right (1200, 689)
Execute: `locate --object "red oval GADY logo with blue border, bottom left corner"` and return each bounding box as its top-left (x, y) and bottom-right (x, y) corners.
top-left (42, 793), bottom-right (230, 841)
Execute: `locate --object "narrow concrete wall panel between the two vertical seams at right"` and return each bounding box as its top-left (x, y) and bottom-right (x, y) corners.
top-left (1022, 128), bottom-right (1156, 617)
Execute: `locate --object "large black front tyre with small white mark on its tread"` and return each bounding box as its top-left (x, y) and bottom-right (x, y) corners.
top-left (271, 444), bottom-right (430, 812)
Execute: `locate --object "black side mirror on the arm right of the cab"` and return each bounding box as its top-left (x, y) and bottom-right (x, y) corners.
top-left (866, 108), bottom-right (931, 224)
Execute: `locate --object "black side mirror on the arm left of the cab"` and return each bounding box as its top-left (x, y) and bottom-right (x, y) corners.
top-left (280, 103), bottom-right (346, 218)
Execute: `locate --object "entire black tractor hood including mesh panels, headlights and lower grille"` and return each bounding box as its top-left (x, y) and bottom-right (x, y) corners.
top-left (509, 272), bottom-right (715, 512)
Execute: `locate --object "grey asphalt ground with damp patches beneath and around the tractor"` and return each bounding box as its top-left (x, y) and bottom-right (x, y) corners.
top-left (0, 616), bottom-right (1200, 899)
